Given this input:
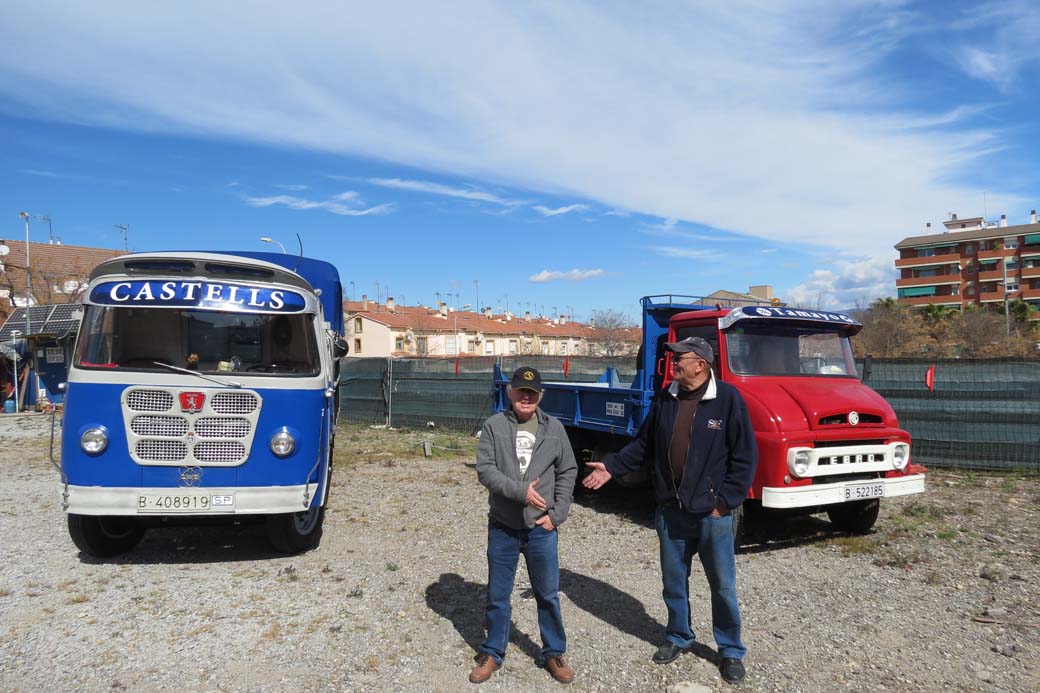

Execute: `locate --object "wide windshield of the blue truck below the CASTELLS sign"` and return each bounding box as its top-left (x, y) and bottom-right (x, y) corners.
top-left (76, 306), bottom-right (320, 376)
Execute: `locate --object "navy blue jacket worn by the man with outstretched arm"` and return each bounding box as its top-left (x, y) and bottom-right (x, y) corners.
top-left (603, 374), bottom-right (758, 513)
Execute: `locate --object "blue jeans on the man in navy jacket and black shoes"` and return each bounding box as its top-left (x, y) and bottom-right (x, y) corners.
top-left (655, 505), bottom-right (747, 660)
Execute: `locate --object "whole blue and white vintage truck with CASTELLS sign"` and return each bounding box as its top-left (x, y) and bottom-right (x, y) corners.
top-left (60, 252), bottom-right (346, 557)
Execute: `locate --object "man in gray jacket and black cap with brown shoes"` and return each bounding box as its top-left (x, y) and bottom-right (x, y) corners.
top-left (469, 367), bottom-right (577, 684)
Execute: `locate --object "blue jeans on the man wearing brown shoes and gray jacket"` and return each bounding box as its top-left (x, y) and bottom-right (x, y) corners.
top-left (479, 520), bottom-right (567, 664)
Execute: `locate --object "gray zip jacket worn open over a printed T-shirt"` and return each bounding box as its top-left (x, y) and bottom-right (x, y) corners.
top-left (476, 409), bottom-right (578, 530)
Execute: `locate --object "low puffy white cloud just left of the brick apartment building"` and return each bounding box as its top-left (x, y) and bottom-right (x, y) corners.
top-left (781, 258), bottom-right (896, 309)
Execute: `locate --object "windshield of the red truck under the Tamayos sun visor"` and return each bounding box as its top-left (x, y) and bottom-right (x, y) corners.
top-left (726, 323), bottom-right (857, 378)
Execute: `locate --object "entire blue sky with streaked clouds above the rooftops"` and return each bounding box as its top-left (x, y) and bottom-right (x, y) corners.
top-left (0, 0), bottom-right (1040, 319)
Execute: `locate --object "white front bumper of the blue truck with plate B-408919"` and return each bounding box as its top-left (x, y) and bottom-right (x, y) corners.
top-left (62, 484), bottom-right (316, 516)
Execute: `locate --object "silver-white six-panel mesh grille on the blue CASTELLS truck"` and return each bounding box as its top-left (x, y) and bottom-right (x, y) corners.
top-left (123, 387), bottom-right (263, 466)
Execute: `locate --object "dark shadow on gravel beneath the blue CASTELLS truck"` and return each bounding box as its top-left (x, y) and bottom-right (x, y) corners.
top-left (70, 523), bottom-right (286, 565)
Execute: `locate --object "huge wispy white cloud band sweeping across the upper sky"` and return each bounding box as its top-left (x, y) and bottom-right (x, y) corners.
top-left (0, 0), bottom-right (1027, 256)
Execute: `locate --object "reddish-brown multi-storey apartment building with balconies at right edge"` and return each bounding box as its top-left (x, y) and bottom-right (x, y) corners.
top-left (895, 209), bottom-right (1040, 308)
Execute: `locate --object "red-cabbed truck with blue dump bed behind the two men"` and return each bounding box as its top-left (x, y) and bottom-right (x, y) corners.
top-left (496, 296), bottom-right (926, 542)
